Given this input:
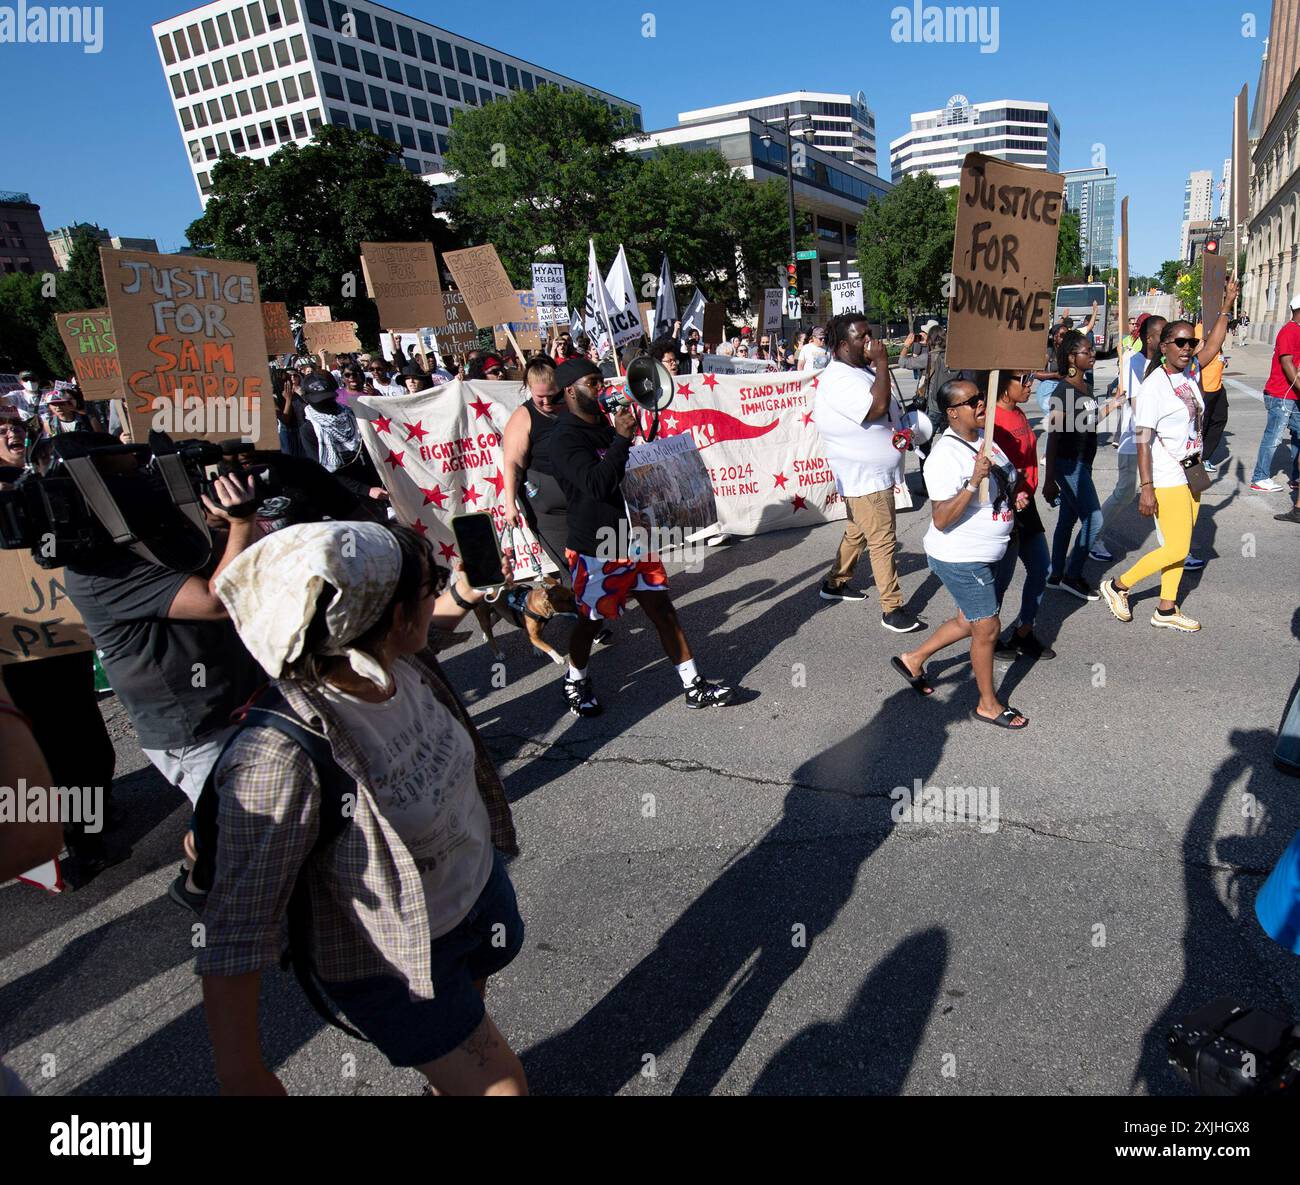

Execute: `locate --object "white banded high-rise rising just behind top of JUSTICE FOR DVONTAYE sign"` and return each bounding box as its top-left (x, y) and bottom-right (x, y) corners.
top-left (889, 95), bottom-right (1061, 188)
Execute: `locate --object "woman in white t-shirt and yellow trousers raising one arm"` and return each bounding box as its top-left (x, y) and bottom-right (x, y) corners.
top-left (1100, 301), bottom-right (1236, 634)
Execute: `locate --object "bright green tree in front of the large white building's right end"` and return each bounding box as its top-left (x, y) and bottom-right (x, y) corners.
top-left (446, 86), bottom-right (637, 287)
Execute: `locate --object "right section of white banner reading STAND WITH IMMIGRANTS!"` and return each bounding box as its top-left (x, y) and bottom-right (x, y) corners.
top-left (611, 372), bottom-right (844, 535)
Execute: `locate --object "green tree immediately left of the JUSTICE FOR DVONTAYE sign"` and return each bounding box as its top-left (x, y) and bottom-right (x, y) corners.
top-left (858, 173), bottom-right (956, 325)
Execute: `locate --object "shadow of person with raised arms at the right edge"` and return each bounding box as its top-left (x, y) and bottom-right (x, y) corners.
top-left (1131, 729), bottom-right (1300, 1094)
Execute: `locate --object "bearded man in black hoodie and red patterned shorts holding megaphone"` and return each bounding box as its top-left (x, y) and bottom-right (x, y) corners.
top-left (550, 359), bottom-right (736, 716)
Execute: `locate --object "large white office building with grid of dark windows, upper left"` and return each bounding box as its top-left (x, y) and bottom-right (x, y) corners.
top-left (153, 0), bottom-right (641, 200)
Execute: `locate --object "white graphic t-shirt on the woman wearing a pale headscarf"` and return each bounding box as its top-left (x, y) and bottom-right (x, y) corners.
top-left (322, 663), bottom-right (493, 938)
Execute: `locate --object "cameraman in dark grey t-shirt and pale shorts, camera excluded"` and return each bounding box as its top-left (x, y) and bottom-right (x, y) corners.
top-left (65, 454), bottom-right (265, 908)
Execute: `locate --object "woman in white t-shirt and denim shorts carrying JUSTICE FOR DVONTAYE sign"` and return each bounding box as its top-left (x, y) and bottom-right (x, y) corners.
top-left (889, 378), bottom-right (1030, 730)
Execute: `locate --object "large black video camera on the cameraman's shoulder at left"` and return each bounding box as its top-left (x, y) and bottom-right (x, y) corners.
top-left (0, 431), bottom-right (312, 572)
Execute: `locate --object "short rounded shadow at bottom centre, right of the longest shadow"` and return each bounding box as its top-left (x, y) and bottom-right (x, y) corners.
top-left (753, 926), bottom-right (948, 1094)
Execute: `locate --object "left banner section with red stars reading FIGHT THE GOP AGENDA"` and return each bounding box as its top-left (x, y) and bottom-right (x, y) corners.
top-left (351, 379), bottom-right (556, 581)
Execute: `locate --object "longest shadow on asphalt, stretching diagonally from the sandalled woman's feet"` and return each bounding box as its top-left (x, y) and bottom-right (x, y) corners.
top-left (523, 689), bottom-right (954, 1094)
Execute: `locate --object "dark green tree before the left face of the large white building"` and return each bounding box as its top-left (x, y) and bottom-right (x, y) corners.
top-left (189, 126), bottom-right (447, 343)
